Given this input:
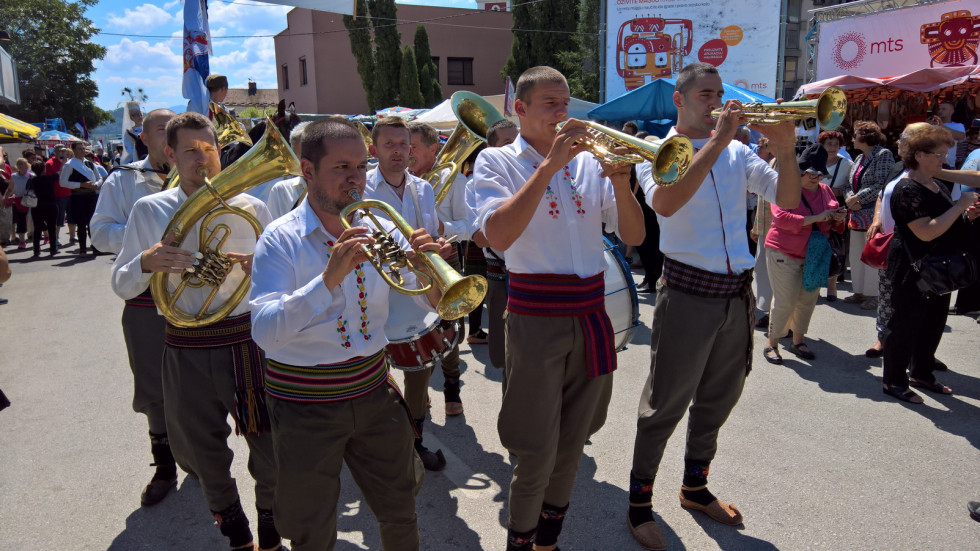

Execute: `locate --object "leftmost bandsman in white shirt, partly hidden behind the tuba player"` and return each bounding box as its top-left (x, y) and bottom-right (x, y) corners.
top-left (91, 109), bottom-right (177, 506)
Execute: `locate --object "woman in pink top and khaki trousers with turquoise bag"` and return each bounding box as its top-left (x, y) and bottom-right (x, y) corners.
top-left (764, 144), bottom-right (846, 364)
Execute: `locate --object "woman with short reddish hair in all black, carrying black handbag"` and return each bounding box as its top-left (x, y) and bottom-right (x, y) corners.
top-left (882, 126), bottom-right (980, 404)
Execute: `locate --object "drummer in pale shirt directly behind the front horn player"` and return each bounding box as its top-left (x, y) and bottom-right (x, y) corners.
top-left (364, 117), bottom-right (450, 471)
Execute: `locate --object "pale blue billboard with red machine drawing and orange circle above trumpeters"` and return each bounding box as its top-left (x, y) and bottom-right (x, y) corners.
top-left (605, 0), bottom-right (780, 101)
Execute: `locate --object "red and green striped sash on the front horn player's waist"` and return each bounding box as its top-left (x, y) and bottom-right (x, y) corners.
top-left (265, 348), bottom-right (397, 402)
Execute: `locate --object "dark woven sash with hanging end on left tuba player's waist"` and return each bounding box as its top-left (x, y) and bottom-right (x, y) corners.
top-left (165, 314), bottom-right (271, 436)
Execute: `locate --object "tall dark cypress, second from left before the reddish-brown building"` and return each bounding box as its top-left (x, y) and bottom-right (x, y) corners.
top-left (368, 0), bottom-right (402, 109)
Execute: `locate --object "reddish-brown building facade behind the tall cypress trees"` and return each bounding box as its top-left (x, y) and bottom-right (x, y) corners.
top-left (275, 4), bottom-right (513, 114)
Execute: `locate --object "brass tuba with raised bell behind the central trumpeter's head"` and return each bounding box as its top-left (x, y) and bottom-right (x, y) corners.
top-left (422, 90), bottom-right (504, 206)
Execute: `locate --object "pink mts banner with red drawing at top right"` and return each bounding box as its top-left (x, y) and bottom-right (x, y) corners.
top-left (817, 0), bottom-right (980, 80)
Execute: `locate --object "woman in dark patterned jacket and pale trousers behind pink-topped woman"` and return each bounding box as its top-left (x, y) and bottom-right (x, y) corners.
top-left (844, 121), bottom-right (895, 310)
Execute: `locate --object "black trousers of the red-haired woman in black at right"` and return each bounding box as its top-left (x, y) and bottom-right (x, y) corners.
top-left (882, 276), bottom-right (950, 388)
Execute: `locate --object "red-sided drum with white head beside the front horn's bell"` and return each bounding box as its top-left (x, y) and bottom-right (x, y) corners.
top-left (385, 292), bottom-right (460, 371)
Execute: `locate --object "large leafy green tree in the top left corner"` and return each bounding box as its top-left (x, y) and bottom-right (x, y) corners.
top-left (0, 0), bottom-right (112, 127)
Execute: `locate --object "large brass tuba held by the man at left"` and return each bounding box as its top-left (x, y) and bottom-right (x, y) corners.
top-left (150, 114), bottom-right (300, 327)
